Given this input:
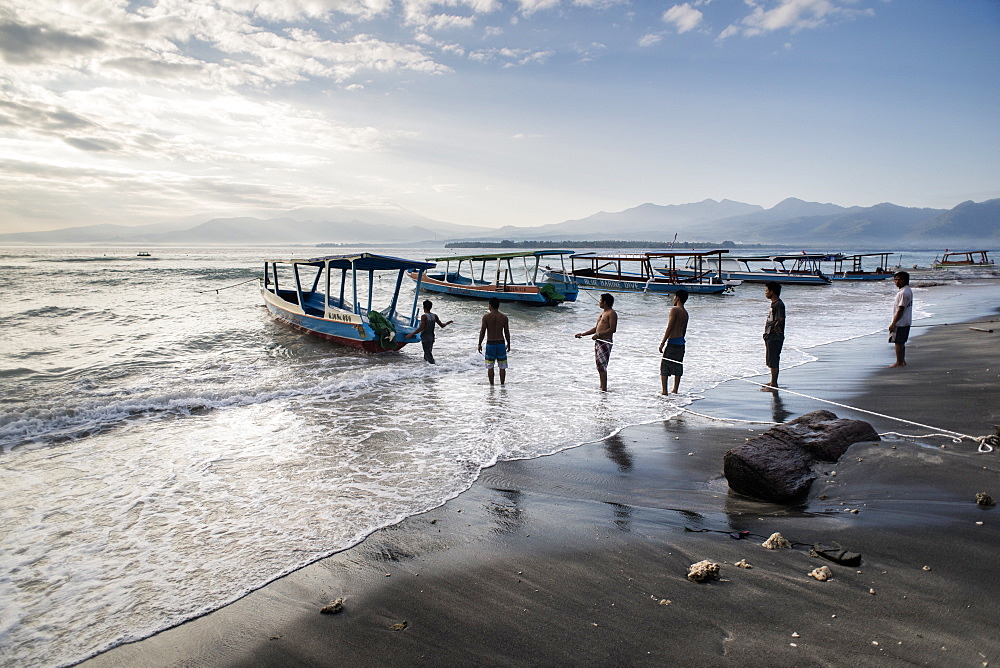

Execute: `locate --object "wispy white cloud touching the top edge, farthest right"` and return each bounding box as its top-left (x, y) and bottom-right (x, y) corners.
top-left (719, 0), bottom-right (874, 39)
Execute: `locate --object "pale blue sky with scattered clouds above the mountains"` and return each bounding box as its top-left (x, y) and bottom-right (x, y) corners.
top-left (0, 0), bottom-right (1000, 232)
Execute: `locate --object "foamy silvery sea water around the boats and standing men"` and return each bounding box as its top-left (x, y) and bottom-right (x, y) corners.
top-left (0, 247), bottom-right (996, 666)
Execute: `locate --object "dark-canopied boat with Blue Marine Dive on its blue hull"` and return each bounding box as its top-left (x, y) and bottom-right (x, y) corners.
top-left (548, 250), bottom-right (738, 294)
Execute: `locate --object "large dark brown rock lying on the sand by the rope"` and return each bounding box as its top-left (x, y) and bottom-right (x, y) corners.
top-left (723, 411), bottom-right (880, 503)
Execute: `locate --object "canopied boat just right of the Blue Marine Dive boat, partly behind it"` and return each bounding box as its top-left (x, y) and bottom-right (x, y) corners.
top-left (657, 254), bottom-right (830, 285)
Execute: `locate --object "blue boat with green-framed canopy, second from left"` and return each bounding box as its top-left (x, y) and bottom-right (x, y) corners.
top-left (410, 250), bottom-right (579, 306)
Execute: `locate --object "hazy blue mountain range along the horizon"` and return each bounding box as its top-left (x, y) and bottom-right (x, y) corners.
top-left (0, 198), bottom-right (1000, 249)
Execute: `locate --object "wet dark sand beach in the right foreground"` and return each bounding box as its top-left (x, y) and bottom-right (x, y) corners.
top-left (83, 318), bottom-right (1000, 668)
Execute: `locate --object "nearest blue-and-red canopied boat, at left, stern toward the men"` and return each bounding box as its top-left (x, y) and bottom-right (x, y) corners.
top-left (260, 253), bottom-right (434, 353)
